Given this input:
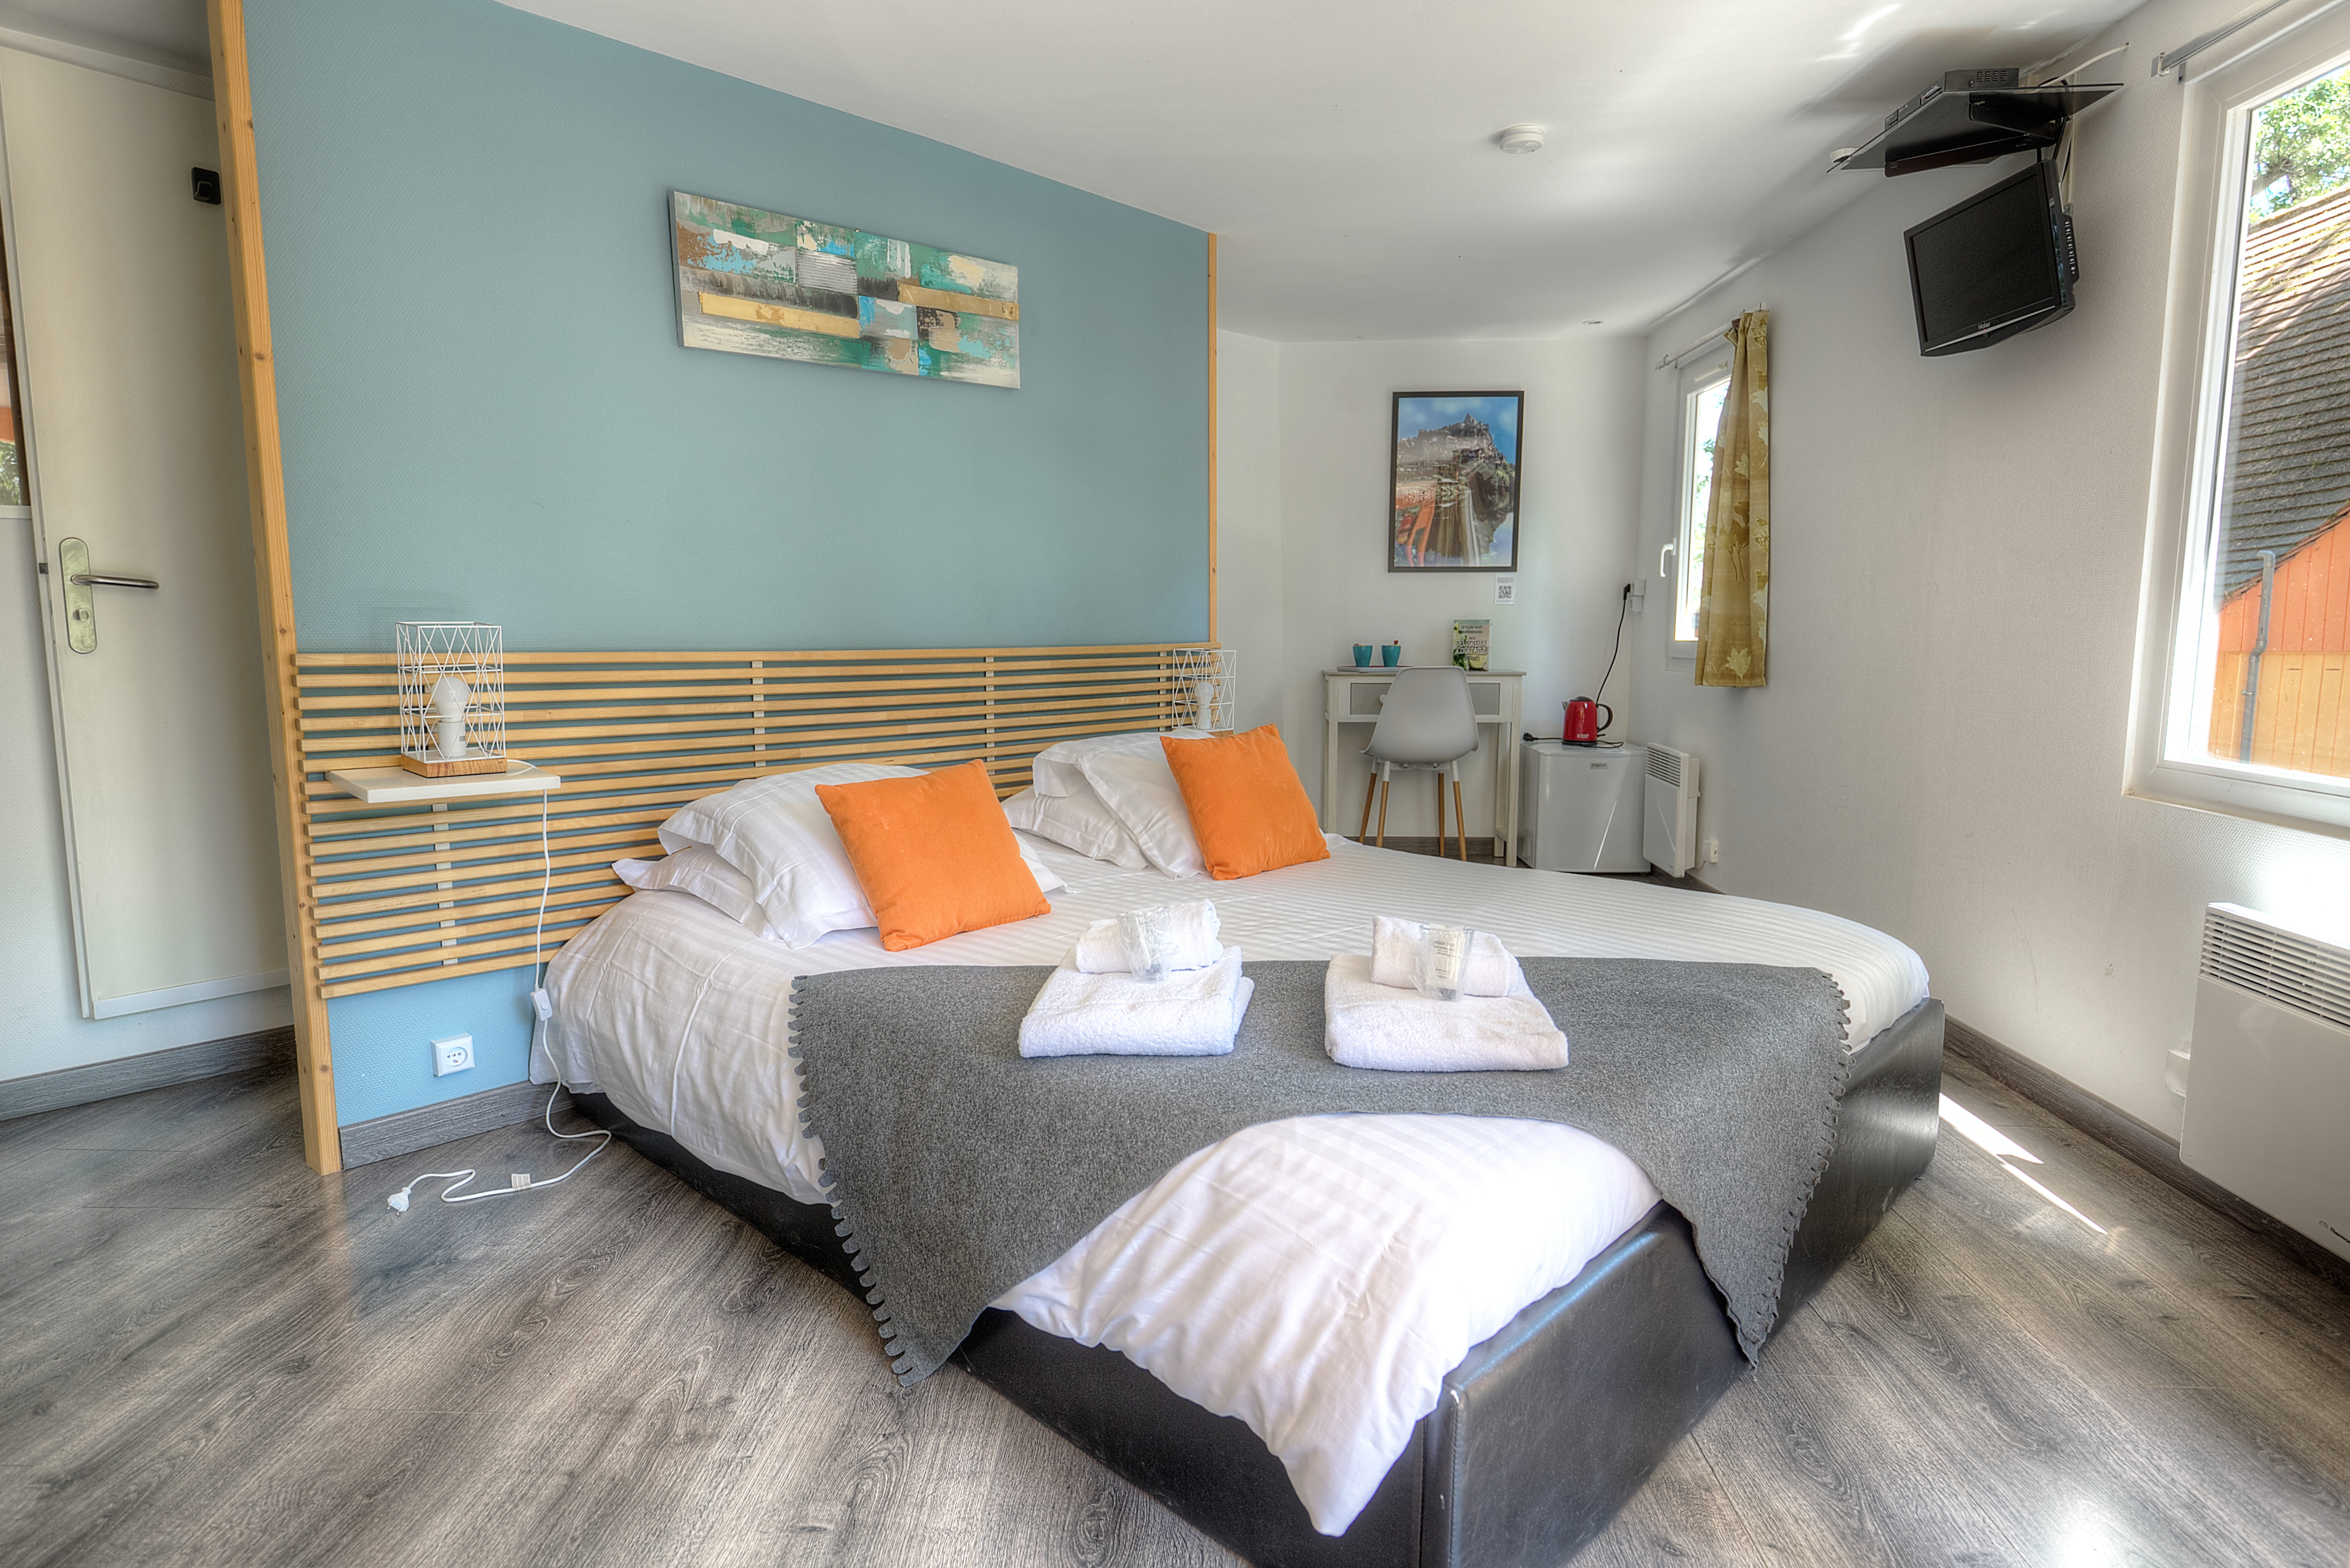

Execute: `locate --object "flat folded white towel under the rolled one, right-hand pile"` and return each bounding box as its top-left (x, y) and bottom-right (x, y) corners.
top-left (1323, 952), bottom-right (1567, 1072)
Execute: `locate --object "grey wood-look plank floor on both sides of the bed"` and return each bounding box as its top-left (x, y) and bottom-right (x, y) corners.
top-left (0, 1063), bottom-right (2350, 1568)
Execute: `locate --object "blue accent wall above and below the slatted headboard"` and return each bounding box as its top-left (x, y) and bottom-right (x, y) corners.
top-left (247, 0), bottom-right (1208, 1122)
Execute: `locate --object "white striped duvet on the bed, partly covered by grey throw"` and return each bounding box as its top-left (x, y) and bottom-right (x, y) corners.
top-left (534, 839), bottom-right (1927, 1535)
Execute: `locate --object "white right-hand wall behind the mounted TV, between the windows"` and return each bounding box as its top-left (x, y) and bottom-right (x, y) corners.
top-left (1636, 0), bottom-right (2350, 1131)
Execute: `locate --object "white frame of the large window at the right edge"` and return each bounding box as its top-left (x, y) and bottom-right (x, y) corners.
top-left (2124, 14), bottom-right (2350, 837)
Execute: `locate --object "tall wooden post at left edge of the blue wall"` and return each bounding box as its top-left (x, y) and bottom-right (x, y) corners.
top-left (204, 0), bottom-right (343, 1173)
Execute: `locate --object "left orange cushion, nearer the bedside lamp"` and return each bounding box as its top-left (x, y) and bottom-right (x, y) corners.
top-left (816, 762), bottom-right (1053, 952)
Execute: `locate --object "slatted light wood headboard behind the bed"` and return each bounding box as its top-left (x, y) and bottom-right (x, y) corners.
top-left (294, 644), bottom-right (1201, 997)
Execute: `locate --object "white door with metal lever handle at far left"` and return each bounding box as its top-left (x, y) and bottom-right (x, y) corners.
top-left (0, 50), bottom-right (287, 1018)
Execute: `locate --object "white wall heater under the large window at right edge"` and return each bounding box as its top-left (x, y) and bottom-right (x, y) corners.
top-left (2178, 903), bottom-right (2350, 1258)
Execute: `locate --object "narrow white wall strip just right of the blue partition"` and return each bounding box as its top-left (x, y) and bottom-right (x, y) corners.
top-left (1215, 331), bottom-right (1288, 734)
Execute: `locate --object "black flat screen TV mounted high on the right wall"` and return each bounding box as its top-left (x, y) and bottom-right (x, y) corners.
top-left (1901, 162), bottom-right (2077, 355)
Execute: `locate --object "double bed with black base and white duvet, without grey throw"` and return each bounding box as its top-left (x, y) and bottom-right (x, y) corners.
top-left (534, 839), bottom-right (1941, 1566)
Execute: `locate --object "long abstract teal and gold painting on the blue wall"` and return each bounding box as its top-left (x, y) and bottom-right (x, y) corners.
top-left (670, 190), bottom-right (1020, 385)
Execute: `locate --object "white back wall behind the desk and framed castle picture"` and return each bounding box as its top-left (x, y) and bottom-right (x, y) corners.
top-left (1269, 338), bottom-right (1640, 837)
